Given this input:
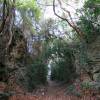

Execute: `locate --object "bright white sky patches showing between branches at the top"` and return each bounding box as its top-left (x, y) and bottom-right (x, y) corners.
top-left (44, 0), bottom-right (85, 19)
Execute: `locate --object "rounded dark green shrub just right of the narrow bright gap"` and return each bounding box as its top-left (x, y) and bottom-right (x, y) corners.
top-left (51, 53), bottom-right (76, 82)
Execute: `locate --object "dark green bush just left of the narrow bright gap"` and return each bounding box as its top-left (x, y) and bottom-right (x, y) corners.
top-left (27, 60), bottom-right (47, 91)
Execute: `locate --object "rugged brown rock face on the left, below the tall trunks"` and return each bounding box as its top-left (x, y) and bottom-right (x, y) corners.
top-left (0, 28), bottom-right (29, 93)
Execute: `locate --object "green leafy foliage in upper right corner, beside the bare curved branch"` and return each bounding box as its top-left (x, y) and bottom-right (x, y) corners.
top-left (78, 0), bottom-right (100, 43)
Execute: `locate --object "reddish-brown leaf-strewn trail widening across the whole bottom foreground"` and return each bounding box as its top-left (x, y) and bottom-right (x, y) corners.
top-left (9, 80), bottom-right (97, 100)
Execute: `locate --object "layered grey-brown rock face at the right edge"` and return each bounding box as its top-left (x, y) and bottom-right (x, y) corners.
top-left (88, 36), bottom-right (100, 81)
